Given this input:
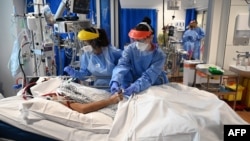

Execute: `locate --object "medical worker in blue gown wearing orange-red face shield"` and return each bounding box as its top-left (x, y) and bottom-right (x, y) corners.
top-left (110, 17), bottom-right (168, 96)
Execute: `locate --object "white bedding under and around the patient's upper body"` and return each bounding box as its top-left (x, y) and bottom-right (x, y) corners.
top-left (0, 77), bottom-right (118, 141)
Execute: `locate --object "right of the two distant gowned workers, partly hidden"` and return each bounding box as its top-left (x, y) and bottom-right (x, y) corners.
top-left (191, 20), bottom-right (205, 60)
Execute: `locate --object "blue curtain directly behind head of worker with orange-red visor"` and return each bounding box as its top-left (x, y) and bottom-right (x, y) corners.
top-left (119, 8), bottom-right (157, 49)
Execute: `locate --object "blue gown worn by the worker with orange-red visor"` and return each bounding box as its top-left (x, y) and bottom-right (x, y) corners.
top-left (110, 42), bottom-right (168, 92)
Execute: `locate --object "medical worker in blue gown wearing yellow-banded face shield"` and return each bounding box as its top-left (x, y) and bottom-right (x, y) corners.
top-left (64, 27), bottom-right (122, 86)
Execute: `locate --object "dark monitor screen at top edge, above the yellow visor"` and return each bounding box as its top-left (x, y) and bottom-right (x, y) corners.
top-left (72, 0), bottom-right (90, 14)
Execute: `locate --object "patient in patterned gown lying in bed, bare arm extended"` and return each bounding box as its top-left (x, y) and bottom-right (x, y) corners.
top-left (21, 79), bottom-right (123, 118)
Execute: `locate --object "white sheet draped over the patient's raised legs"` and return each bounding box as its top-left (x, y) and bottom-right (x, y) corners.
top-left (108, 83), bottom-right (248, 141)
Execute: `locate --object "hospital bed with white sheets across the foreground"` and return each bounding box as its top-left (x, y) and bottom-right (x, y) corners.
top-left (0, 78), bottom-right (248, 141)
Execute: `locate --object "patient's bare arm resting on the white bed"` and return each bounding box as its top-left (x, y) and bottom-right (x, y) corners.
top-left (68, 94), bottom-right (123, 114)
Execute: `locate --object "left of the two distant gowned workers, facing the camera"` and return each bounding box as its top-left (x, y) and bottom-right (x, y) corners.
top-left (182, 21), bottom-right (199, 60)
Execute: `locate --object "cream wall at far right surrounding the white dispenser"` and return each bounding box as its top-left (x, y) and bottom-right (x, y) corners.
top-left (198, 0), bottom-right (250, 69)
